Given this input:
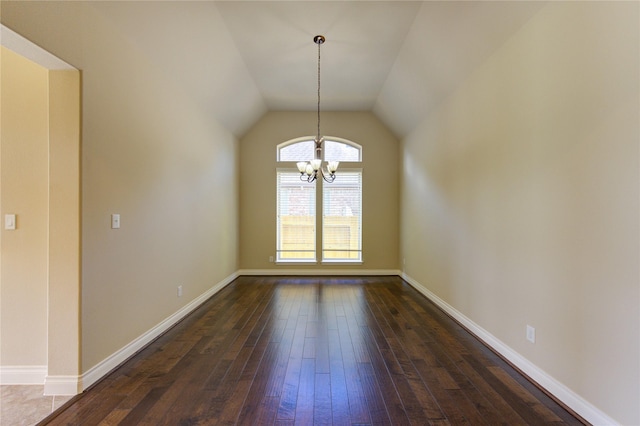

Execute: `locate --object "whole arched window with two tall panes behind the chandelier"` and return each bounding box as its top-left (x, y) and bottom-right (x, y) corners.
top-left (276, 136), bottom-right (362, 263)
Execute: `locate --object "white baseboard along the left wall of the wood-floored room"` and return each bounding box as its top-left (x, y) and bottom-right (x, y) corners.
top-left (80, 272), bottom-right (239, 391)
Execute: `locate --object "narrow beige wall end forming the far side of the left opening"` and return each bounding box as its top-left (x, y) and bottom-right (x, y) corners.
top-left (45, 70), bottom-right (82, 382)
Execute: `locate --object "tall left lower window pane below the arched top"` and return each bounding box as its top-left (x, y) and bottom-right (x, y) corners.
top-left (276, 171), bottom-right (316, 261)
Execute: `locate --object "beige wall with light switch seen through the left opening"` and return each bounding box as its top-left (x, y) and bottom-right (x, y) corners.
top-left (0, 47), bottom-right (49, 367)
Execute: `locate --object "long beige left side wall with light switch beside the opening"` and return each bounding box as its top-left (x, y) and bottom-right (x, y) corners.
top-left (2, 2), bottom-right (238, 372)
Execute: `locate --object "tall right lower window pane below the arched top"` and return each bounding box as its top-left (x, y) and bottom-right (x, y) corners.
top-left (322, 171), bottom-right (362, 261)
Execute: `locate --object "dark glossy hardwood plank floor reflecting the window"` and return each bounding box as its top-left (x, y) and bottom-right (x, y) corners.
top-left (42, 277), bottom-right (583, 426)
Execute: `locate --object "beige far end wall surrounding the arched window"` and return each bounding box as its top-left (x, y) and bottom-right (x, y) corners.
top-left (240, 112), bottom-right (398, 270)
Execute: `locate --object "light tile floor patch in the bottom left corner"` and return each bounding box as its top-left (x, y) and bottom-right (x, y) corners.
top-left (0, 385), bottom-right (72, 426)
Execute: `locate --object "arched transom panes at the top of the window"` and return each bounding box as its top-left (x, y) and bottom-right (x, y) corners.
top-left (277, 136), bottom-right (362, 162)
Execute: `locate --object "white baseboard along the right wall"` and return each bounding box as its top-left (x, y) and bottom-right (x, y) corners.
top-left (401, 272), bottom-right (618, 426)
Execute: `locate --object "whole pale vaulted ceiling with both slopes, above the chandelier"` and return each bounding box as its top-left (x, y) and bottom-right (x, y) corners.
top-left (2, 1), bottom-right (543, 136)
